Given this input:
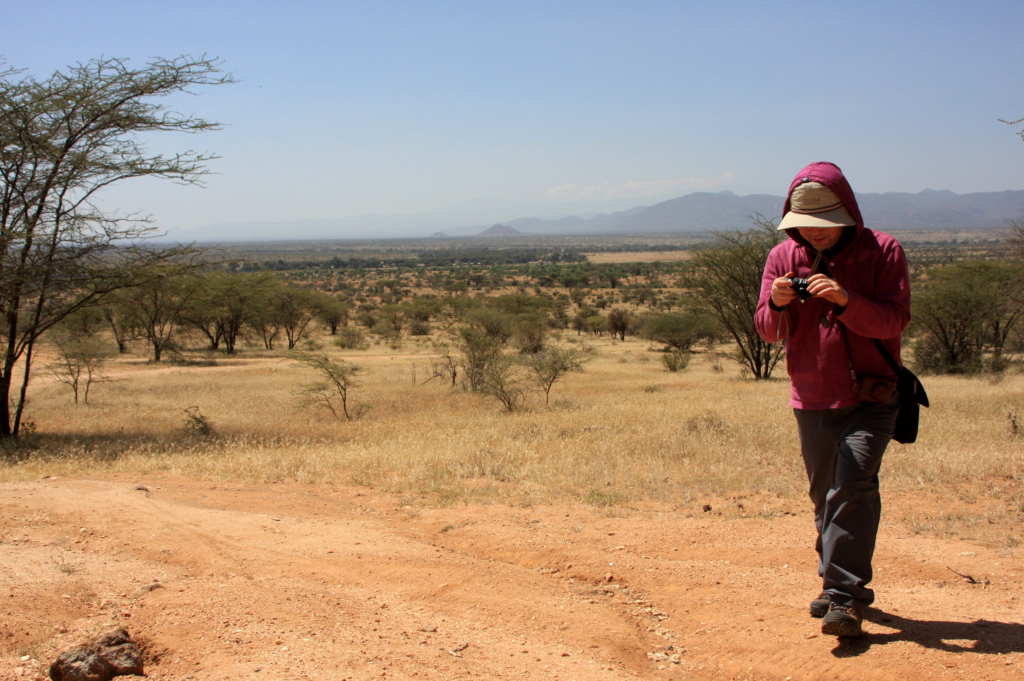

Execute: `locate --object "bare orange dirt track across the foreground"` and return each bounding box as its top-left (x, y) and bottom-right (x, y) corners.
top-left (0, 477), bottom-right (1024, 681)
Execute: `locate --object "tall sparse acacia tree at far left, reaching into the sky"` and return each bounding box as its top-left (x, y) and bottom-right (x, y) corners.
top-left (0, 56), bottom-right (230, 436)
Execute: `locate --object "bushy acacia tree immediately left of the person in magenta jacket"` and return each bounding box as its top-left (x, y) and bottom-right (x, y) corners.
top-left (683, 213), bottom-right (784, 379)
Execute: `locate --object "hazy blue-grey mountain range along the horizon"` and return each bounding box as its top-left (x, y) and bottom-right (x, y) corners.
top-left (151, 189), bottom-right (1024, 242)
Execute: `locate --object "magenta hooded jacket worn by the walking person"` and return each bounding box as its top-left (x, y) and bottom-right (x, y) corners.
top-left (755, 163), bottom-right (910, 410)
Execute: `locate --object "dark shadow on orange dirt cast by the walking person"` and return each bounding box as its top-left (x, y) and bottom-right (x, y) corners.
top-left (833, 607), bottom-right (1024, 657)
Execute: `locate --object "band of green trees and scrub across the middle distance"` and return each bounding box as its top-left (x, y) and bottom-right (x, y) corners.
top-left (51, 236), bottom-right (1024, 378)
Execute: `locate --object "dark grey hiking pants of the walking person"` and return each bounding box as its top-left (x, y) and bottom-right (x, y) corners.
top-left (794, 392), bottom-right (899, 610)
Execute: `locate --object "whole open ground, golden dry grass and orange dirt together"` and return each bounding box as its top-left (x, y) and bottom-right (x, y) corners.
top-left (0, 235), bottom-right (1024, 681)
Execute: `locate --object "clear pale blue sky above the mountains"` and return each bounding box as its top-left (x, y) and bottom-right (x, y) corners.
top-left (0, 0), bottom-right (1024, 235)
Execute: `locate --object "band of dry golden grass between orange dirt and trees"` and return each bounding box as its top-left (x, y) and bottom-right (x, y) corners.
top-left (8, 336), bottom-right (1024, 526)
